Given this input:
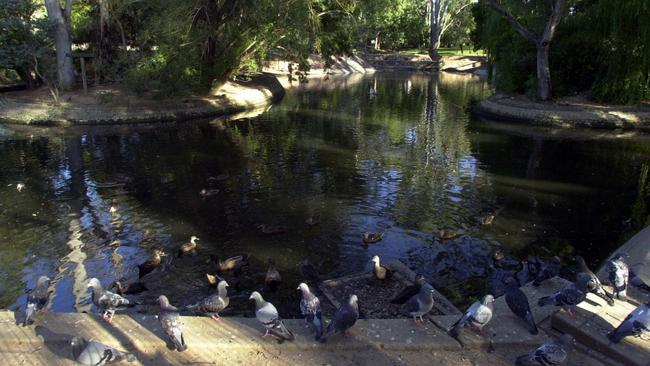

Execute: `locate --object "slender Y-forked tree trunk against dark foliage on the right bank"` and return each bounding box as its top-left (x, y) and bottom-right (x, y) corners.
top-left (482, 0), bottom-right (565, 100)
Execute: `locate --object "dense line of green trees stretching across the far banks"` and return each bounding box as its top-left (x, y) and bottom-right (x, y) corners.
top-left (0, 0), bottom-right (650, 103)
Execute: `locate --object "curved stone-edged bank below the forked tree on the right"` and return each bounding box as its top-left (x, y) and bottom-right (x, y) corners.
top-left (474, 95), bottom-right (650, 130)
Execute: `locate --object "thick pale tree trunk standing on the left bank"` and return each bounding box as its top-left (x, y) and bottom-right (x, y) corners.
top-left (45, 0), bottom-right (74, 90)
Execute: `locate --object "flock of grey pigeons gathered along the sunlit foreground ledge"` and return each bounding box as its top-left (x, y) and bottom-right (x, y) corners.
top-left (24, 237), bottom-right (650, 365)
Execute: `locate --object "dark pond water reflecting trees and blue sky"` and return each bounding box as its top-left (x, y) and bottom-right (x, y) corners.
top-left (0, 74), bottom-right (650, 317)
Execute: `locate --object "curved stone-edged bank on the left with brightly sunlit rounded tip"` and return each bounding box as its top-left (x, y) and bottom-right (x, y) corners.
top-left (0, 74), bottom-right (284, 126)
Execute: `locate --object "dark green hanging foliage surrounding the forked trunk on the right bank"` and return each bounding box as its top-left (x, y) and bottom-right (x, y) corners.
top-left (470, 0), bottom-right (650, 103)
